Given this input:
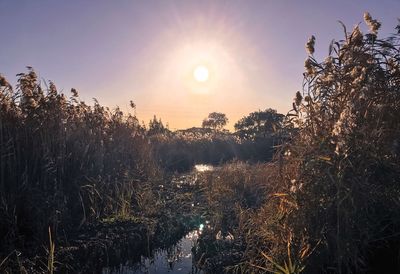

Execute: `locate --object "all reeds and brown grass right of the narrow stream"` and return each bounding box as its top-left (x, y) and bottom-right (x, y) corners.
top-left (197, 13), bottom-right (400, 273)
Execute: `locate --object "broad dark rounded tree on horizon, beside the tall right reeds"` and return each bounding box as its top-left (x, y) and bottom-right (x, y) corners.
top-left (235, 108), bottom-right (285, 138)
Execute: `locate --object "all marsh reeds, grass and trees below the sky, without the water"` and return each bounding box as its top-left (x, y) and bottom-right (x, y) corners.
top-left (0, 13), bottom-right (400, 274)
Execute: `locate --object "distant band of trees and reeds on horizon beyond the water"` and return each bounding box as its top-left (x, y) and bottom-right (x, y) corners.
top-left (147, 109), bottom-right (290, 172)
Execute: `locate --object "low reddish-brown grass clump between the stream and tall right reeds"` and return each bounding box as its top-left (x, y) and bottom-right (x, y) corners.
top-left (198, 162), bottom-right (271, 235)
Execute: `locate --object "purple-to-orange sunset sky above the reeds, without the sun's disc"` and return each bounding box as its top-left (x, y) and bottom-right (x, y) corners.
top-left (0, 0), bottom-right (400, 129)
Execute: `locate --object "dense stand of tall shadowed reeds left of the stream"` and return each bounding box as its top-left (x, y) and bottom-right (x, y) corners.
top-left (0, 67), bottom-right (160, 255)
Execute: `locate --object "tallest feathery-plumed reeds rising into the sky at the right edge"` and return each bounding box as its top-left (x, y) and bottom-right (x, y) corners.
top-left (288, 13), bottom-right (400, 273)
